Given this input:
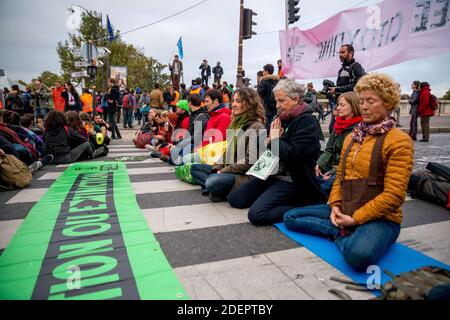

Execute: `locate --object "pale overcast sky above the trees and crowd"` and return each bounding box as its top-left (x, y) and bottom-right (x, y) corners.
top-left (0, 0), bottom-right (450, 96)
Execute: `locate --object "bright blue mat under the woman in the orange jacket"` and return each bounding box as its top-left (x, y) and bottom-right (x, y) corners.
top-left (275, 223), bottom-right (450, 294)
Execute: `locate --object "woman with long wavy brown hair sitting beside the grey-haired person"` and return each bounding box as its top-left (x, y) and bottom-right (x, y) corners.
top-left (191, 88), bottom-right (266, 202)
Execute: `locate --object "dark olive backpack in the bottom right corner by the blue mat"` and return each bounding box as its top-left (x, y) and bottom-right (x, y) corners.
top-left (373, 266), bottom-right (450, 300)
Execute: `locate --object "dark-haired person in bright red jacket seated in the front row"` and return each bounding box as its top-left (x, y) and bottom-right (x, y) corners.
top-left (202, 90), bottom-right (231, 147)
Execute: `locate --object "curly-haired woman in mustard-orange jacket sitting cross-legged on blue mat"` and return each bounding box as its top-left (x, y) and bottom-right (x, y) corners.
top-left (284, 74), bottom-right (414, 272)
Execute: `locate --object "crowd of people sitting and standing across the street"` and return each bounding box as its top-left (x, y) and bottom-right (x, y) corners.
top-left (0, 45), bottom-right (440, 271)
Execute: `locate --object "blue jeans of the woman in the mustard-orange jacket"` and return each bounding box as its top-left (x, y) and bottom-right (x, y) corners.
top-left (284, 204), bottom-right (400, 272)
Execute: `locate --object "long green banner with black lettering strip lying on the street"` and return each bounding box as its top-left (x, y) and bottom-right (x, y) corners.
top-left (0, 162), bottom-right (188, 300)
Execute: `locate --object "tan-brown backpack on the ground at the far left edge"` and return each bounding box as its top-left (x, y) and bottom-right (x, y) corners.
top-left (0, 154), bottom-right (33, 189)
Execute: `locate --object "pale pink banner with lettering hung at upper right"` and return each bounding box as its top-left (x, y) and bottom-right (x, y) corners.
top-left (280, 0), bottom-right (450, 79)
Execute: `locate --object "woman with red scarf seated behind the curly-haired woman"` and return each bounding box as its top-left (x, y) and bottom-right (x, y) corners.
top-left (315, 92), bottom-right (362, 195)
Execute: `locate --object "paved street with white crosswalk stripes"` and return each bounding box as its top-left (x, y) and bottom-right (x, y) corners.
top-left (0, 127), bottom-right (450, 299)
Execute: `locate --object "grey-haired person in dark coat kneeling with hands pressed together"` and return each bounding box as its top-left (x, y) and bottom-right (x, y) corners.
top-left (228, 80), bottom-right (327, 225)
